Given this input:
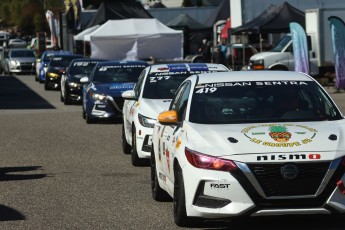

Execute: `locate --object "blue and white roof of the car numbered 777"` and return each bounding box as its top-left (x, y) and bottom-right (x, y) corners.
top-left (146, 63), bottom-right (229, 73)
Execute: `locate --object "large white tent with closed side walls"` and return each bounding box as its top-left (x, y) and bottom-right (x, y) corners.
top-left (84, 18), bottom-right (183, 60)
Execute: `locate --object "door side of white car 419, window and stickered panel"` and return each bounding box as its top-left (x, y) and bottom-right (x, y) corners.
top-left (161, 81), bottom-right (191, 183)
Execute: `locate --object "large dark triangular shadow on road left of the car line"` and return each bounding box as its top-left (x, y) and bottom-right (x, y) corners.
top-left (0, 76), bottom-right (55, 109)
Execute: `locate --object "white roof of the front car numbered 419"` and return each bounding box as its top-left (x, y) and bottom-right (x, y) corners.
top-left (192, 70), bottom-right (315, 84)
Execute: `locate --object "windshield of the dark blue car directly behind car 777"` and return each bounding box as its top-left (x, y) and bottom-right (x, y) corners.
top-left (93, 64), bottom-right (146, 83)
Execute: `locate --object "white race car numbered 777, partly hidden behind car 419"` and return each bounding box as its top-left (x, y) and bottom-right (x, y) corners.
top-left (122, 63), bottom-right (229, 166)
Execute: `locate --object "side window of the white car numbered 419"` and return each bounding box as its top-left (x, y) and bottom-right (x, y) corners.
top-left (171, 81), bottom-right (191, 121)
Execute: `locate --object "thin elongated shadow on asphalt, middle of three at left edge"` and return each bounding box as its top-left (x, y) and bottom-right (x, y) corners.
top-left (0, 166), bottom-right (47, 181)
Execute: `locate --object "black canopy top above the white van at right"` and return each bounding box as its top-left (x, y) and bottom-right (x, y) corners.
top-left (231, 2), bottom-right (305, 34)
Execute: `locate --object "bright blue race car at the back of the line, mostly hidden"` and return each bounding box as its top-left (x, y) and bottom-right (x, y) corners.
top-left (35, 50), bottom-right (71, 83)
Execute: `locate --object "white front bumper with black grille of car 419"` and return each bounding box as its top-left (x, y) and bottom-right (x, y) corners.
top-left (181, 159), bottom-right (345, 218)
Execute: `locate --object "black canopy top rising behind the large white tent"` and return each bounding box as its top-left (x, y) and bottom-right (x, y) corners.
top-left (87, 0), bottom-right (153, 28)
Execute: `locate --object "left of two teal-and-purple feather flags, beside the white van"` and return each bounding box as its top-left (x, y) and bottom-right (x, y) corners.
top-left (289, 22), bottom-right (309, 74)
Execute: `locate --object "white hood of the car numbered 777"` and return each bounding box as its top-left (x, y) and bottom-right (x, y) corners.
top-left (138, 99), bottom-right (171, 119)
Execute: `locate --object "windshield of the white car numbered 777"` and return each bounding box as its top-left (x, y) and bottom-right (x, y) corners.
top-left (142, 72), bottom-right (191, 99)
